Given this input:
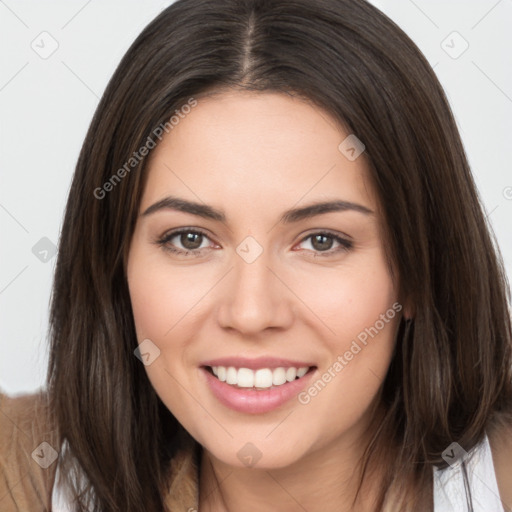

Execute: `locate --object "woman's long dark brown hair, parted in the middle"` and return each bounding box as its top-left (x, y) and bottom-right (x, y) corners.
top-left (48, 0), bottom-right (512, 512)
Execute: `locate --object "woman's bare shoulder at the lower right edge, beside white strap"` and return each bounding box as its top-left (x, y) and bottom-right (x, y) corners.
top-left (487, 418), bottom-right (512, 512)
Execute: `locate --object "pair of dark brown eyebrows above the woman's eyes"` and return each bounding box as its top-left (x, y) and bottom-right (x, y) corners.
top-left (142, 196), bottom-right (374, 224)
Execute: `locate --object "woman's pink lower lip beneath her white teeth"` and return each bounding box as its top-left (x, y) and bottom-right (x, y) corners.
top-left (201, 367), bottom-right (316, 414)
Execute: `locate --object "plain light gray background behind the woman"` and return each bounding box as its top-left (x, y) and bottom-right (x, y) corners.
top-left (0, 0), bottom-right (512, 394)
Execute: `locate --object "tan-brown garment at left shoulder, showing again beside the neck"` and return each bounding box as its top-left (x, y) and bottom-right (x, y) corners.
top-left (0, 391), bottom-right (199, 512)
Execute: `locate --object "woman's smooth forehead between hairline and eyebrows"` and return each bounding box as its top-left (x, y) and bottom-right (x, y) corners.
top-left (141, 92), bottom-right (376, 214)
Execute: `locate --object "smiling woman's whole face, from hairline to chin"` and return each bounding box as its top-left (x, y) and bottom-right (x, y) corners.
top-left (127, 92), bottom-right (401, 468)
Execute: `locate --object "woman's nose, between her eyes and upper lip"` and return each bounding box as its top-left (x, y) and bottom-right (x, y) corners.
top-left (217, 244), bottom-right (295, 336)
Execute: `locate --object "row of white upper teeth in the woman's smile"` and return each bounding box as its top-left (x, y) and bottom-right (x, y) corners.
top-left (212, 366), bottom-right (309, 389)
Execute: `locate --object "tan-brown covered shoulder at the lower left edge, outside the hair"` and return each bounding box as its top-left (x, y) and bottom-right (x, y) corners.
top-left (0, 391), bottom-right (59, 510)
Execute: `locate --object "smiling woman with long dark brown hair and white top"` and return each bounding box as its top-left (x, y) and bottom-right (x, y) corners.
top-left (0, 0), bottom-right (512, 512)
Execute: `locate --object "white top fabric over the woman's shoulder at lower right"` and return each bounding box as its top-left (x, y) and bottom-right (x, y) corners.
top-left (434, 435), bottom-right (505, 512)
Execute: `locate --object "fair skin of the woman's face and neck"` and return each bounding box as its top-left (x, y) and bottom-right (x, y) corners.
top-left (127, 92), bottom-right (407, 512)
